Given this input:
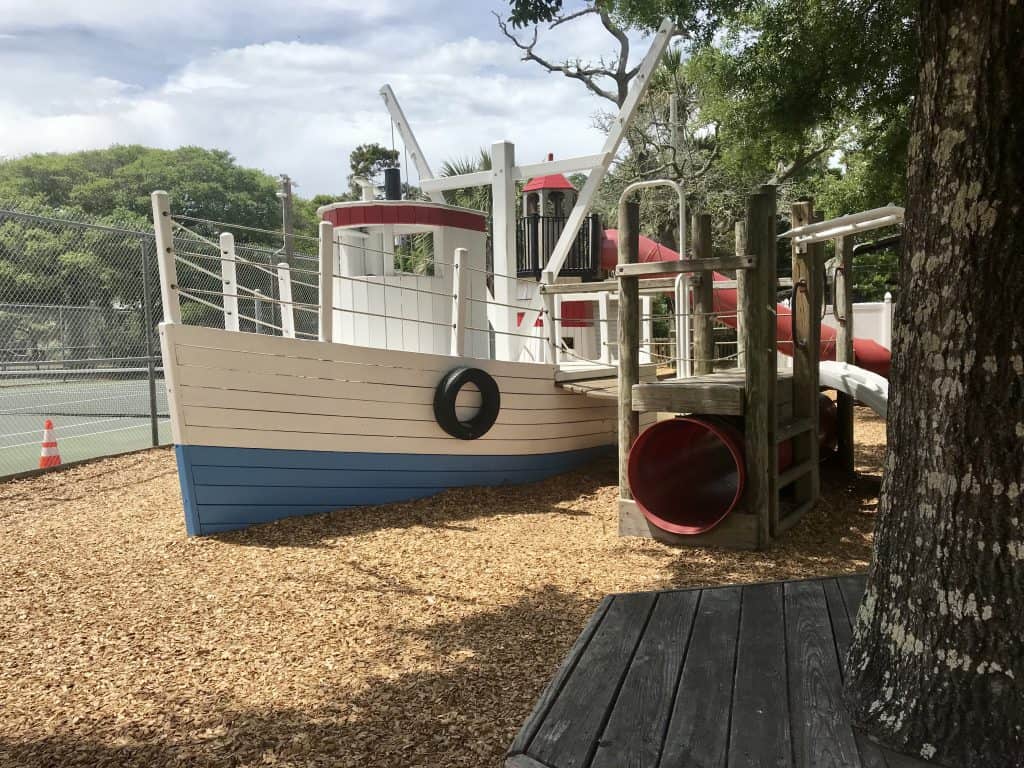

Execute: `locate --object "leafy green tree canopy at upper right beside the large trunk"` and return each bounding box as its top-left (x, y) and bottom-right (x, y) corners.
top-left (509, 0), bottom-right (916, 298)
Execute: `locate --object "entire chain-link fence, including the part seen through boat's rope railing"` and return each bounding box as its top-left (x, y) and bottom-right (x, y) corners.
top-left (0, 204), bottom-right (318, 478)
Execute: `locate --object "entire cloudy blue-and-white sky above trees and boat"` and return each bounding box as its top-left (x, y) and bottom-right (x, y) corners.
top-left (0, 0), bottom-right (646, 197)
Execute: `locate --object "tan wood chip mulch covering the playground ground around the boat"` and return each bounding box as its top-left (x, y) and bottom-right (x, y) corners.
top-left (0, 409), bottom-right (885, 768)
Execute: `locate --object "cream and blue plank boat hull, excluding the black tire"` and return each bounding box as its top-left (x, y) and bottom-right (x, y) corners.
top-left (155, 325), bottom-right (615, 536)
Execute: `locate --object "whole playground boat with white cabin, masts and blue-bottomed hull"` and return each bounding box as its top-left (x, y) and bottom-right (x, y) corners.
top-left (153, 23), bottom-right (888, 536)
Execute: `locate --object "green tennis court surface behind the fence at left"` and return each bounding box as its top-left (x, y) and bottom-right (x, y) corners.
top-left (0, 374), bottom-right (171, 478)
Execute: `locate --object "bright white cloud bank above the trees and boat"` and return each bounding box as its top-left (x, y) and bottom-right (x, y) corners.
top-left (0, 0), bottom-right (646, 196)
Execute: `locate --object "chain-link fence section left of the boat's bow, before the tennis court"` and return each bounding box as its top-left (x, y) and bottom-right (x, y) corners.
top-left (0, 209), bottom-right (170, 477)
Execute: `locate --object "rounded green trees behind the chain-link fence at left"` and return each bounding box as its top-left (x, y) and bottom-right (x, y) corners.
top-left (0, 145), bottom-right (296, 346)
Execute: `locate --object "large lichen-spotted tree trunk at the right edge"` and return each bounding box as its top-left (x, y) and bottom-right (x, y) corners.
top-left (847, 0), bottom-right (1024, 768)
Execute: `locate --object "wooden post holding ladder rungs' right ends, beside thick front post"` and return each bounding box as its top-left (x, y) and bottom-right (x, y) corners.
top-left (792, 202), bottom-right (823, 507)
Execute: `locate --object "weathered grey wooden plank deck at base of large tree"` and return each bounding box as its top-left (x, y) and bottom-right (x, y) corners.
top-left (505, 575), bottom-right (928, 768)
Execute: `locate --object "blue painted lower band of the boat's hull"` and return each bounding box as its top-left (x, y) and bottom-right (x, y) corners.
top-left (175, 445), bottom-right (612, 536)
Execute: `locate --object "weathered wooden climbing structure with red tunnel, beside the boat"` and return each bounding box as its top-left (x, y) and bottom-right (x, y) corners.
top-left (609, 186), bottom-right (902, 548)
